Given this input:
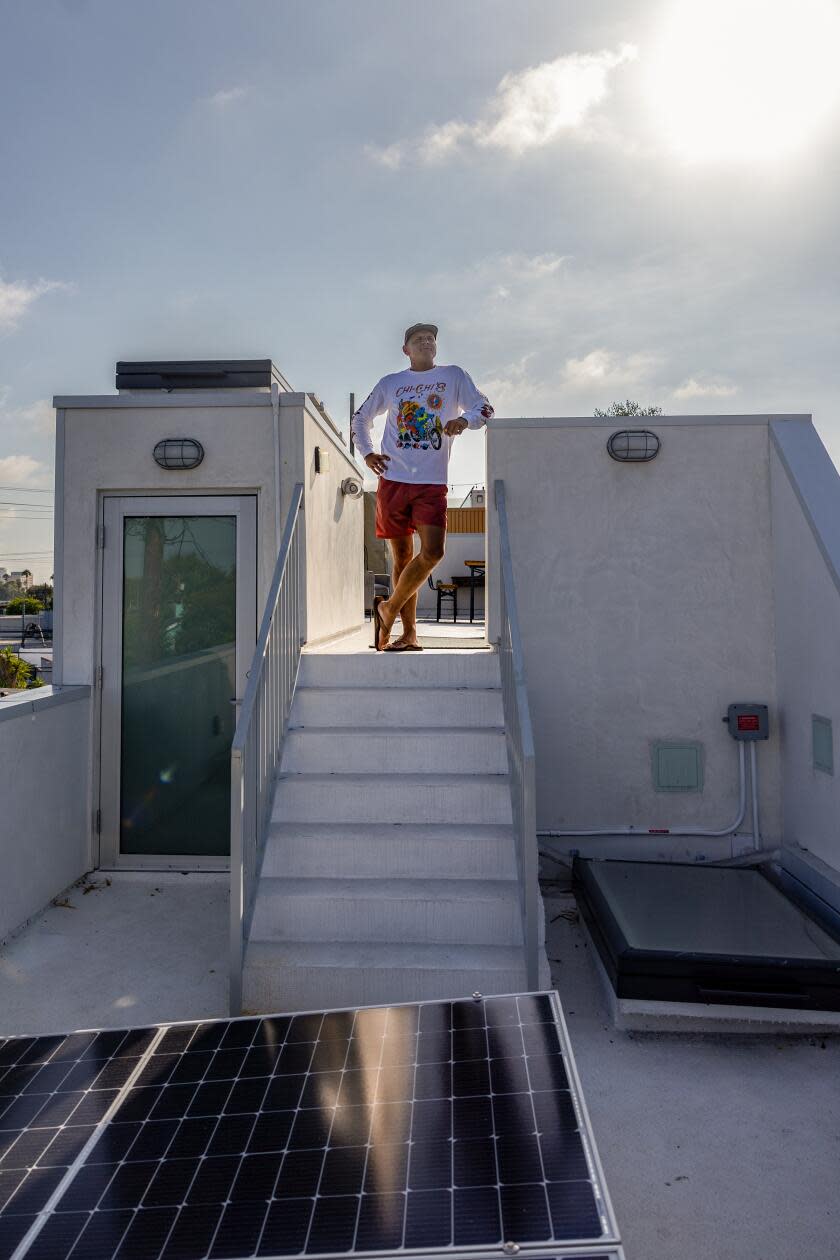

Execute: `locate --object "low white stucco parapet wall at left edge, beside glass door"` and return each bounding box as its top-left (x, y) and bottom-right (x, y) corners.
top-left (0, 687), bottom-right (92, 941)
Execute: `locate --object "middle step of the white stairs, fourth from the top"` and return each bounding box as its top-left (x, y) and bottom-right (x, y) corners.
top-left (272, 774), bottom-right (513, 825)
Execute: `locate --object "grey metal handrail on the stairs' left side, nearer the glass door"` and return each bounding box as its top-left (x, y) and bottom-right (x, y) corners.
top-left (230, 481), bottom-right (304, 1016)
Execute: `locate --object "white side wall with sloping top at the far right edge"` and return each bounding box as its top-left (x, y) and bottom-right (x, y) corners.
top-left (771, 422), bottom-right (840, 872)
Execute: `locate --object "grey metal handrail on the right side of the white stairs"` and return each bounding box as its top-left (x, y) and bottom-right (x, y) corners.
top-left (492, 481), bottom-right (540, 990)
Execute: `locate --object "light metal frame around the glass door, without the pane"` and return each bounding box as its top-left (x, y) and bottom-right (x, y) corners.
top-left (96, 491), bottom-right (258, 871)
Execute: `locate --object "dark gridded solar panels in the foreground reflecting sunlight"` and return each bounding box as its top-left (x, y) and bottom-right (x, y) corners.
top-left (0, 994), bottom-right (621, 1260)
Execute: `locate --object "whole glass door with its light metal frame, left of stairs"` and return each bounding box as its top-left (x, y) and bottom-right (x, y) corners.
top-left (102, 496), bottom-right (256, 867)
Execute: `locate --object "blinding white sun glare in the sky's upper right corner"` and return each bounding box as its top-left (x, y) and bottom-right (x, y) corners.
top-left (645, 0), bottom-right (840, 161)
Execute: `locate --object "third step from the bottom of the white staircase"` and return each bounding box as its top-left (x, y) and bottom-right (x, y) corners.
top-left (262, 823), bottom-right (516, 879)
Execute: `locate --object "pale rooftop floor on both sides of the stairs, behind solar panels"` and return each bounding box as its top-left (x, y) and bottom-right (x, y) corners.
top-left (0, 873), bottom-right (840, 1260)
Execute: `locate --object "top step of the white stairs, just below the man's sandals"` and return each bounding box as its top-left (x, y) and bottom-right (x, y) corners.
top-left (297, 648), bottom-right (501, 688)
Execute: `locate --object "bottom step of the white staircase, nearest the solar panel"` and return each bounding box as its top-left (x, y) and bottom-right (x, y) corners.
top-left (243, 940), bottom-right (541, 1012)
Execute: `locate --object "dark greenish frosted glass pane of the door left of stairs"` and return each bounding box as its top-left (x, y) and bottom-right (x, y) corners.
top-left (120, 517), bottom-right (237, 854)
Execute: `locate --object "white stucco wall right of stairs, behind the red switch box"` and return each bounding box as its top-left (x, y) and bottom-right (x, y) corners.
top-left (487, 417), bottom-right (781, 856)
